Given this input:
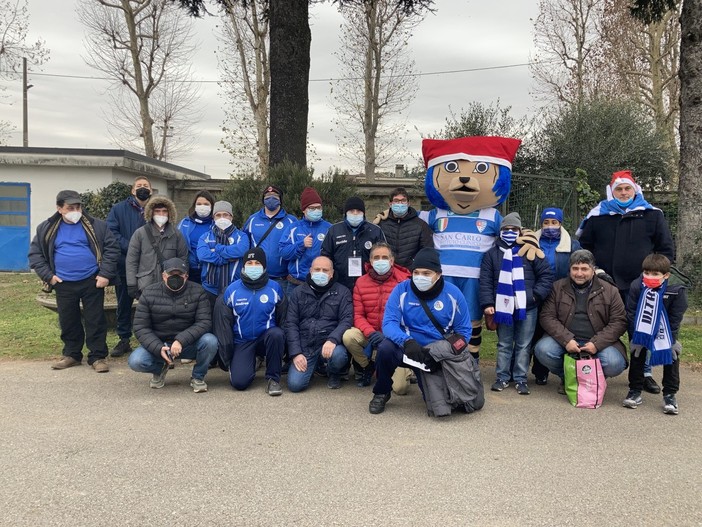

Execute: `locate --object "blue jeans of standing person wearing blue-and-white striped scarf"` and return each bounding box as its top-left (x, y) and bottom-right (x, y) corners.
top-left (495, 306), bottom-right (538, 382)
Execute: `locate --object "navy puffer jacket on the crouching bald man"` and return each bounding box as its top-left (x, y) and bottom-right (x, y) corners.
top-left (285, 283), bottom-right (353, 358)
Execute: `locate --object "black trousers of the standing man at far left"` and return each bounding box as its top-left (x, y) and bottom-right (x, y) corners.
top-left (54, 276), bottom-right (107, 364)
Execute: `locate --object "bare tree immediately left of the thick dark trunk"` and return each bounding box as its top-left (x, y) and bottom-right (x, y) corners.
top-left (218, 0), bottom-right (271, 179)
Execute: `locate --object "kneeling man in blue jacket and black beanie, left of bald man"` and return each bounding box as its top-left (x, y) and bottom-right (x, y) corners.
top-left (215, 247), bottom-right (287, 396)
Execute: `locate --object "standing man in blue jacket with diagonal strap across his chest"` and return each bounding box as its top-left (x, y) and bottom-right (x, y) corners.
top-left (243, 185), bottom-right (297, 287)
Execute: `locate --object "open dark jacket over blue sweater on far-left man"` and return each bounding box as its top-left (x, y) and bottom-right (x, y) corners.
top-left (28, 212), bottom-right (119, 283)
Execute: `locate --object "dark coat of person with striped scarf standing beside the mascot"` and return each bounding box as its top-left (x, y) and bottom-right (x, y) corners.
top-left (479, 240), bottom-right (553, 309)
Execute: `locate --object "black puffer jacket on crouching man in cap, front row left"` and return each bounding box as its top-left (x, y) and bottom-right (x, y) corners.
top-left (134, 281), bottom-right (212, 357)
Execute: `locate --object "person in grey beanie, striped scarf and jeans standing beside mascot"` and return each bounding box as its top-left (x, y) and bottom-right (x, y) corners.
top-left (480, 212), bottom-right (553, 395)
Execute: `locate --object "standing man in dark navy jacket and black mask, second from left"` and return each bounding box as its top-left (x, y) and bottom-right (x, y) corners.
top-left (107, 176), bottom-right (152, 357)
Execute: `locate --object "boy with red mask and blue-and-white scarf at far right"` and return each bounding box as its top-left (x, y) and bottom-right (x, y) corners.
top-left (623, 254), bottom-right (687, 415)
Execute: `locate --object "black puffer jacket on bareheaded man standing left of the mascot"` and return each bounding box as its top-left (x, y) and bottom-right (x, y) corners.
top-left (378, 207), bottom-right (434, 269)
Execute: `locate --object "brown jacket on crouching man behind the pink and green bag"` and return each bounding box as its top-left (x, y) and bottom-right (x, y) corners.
top-left (539, 276), bottom-right (627, 359)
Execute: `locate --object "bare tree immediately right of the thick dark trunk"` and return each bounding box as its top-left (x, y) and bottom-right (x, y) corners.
top-left (332, 0), bottom-right (423, 183)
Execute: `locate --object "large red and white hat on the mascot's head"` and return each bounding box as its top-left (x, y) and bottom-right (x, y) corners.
top-left (422, 136), bottom-right (522, 170)
